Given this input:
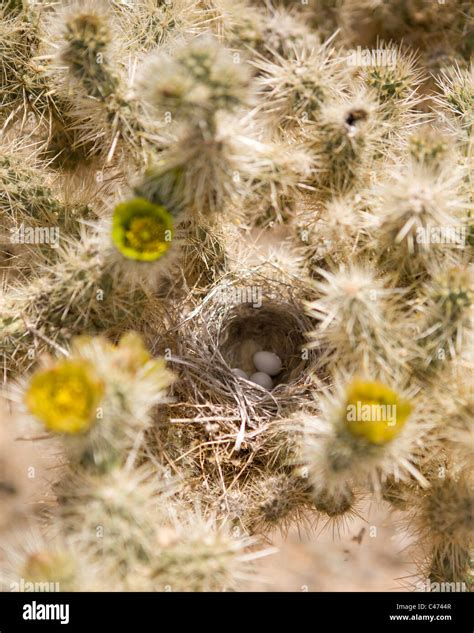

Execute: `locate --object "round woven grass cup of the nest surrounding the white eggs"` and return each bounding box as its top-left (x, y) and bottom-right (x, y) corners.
top-left (159, 267), bottom-right (316, 412)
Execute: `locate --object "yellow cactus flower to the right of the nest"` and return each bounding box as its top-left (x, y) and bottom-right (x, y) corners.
top-left (344, 380), bottom-right (412, 445)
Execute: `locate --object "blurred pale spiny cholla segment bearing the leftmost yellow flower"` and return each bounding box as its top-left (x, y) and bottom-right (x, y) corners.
top-left (25, 333), bottom-right (172, 470)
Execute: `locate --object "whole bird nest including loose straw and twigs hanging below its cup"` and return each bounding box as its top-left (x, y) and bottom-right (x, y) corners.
top-left (148, 267), bottom-right (316, 494)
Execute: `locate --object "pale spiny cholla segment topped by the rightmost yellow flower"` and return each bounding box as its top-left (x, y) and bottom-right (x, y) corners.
top-left (302, 370), bottom-right (429, 504)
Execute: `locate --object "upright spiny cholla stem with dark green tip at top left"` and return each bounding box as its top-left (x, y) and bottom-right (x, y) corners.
top-left (42, 1), bottom-right (156, 161)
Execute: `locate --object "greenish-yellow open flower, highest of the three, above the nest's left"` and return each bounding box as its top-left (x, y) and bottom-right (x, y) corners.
top-left (112, 198), bottom-right (173, 262)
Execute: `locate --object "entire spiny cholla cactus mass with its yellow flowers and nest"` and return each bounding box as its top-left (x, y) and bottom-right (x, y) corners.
top-left (0, 0), bottom-right (474, 591)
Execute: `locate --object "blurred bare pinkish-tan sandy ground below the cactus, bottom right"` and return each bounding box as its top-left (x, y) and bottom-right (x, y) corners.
top-left (250, 504), bottom-right (414, 591)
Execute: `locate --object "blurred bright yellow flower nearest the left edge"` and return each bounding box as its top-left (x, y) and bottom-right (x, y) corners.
top-left (25, 360), bottom-right (104, 433)
